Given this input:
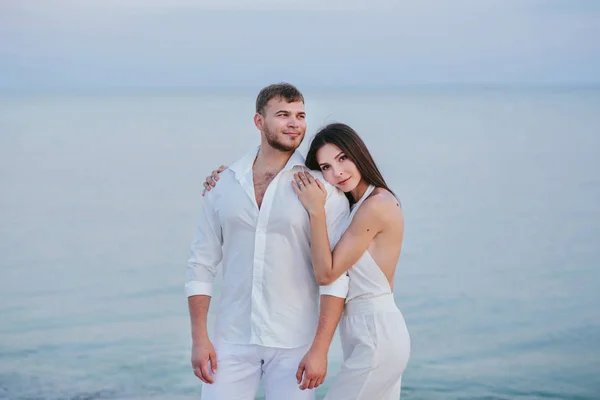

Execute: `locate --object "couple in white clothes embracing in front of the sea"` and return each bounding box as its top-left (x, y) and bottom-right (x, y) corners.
top-left (186, 83), bottom-right (410, 400)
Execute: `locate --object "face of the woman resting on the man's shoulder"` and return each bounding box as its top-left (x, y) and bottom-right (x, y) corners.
top-left (317, 143), bottom-right (362, 192)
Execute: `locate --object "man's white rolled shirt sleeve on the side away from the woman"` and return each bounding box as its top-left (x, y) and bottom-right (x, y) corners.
top-left (185, 192), bottom-right (223, 297)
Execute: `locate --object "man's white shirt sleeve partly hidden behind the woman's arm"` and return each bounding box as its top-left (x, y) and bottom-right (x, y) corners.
top-left (319, 185), bottom-right (350, 299)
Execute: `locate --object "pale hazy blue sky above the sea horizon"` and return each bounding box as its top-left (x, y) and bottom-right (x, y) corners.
top-left (0, 0), bottom-right (600, 89)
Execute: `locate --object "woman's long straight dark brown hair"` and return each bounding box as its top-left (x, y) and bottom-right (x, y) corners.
top-left (306, 123), bottom-right (396, 204)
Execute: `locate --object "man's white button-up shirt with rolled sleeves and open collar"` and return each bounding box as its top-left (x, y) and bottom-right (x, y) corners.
top-left (185, 148), bottom-right (349, 348)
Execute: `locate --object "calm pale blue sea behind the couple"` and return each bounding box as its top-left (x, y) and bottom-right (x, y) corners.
top-left (0, 87), bottom-right (600, 400)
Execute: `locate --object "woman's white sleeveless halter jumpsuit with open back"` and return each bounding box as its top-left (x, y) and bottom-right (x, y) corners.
top-left (325, 186), bottom-right (410, 400)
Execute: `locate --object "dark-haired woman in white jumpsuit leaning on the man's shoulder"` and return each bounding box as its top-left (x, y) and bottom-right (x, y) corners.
top-left (292, 123), bottom-right (410, 400)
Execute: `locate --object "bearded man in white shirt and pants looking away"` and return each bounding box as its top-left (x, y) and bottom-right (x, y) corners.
top-left (186, 83), bottom-right (349, 400)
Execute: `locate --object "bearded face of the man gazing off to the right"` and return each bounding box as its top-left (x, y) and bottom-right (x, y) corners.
top-left (255, 97), bottom-right (306, 152)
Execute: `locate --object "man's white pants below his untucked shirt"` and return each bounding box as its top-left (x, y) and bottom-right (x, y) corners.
top-left (201, 342), bottom-right (315, 400)
